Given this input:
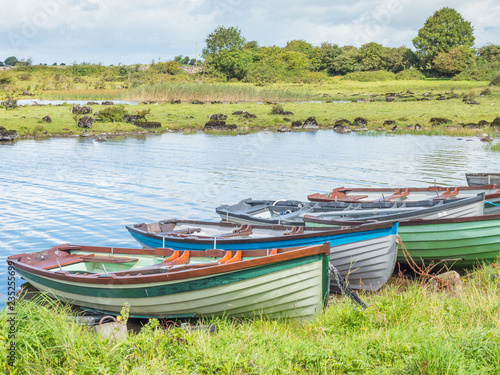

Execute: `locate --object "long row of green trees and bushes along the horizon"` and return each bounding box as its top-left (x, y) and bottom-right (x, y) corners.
top-left (202, 7), bottom-right (500, 83)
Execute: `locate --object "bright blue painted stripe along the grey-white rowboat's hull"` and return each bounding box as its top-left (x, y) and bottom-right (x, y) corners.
top-left (130, 223), bottom-right (398, 251)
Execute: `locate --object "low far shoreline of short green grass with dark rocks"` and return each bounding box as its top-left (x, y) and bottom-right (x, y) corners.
top-left (0, 103), bottom-right (500, 141)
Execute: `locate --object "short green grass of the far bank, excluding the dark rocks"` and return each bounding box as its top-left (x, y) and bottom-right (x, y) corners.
top-left (0, 87), bottom-right (500, 137)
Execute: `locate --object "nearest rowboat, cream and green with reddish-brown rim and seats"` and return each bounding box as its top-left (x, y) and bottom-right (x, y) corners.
top-left (7, 243), bottom-right (330, 319)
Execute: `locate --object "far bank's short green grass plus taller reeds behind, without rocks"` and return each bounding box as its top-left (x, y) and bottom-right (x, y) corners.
top-left (0, 78), bottom-right (500, 137)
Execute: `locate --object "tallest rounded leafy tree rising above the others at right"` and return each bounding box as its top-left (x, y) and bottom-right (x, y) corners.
top-left (413, 7), bottom-right (475, 69)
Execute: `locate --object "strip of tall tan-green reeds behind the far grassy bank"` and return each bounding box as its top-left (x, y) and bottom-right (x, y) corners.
top-left (129, 83), bottom-right (312, 102)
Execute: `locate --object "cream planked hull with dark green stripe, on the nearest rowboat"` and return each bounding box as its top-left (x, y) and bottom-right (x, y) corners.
top-left (9, 245), bottom-right (329, 319)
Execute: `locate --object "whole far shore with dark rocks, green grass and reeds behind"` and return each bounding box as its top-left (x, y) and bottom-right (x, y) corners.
top-left (0, 78), bottom-right (500, 141)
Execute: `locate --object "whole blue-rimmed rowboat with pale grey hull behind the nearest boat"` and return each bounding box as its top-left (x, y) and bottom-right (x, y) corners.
top-left (127, 220), bottom-right (398, 291)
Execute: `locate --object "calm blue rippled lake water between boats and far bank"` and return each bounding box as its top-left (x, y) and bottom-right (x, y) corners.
top-left (0, 130), bottom-right (500, 305)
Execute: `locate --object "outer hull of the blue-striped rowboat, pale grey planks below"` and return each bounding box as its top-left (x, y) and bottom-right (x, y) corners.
top-left (127, 223), bottom-right (398, 291)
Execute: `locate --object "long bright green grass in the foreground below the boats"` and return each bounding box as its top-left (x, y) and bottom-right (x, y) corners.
top-left (0, 265), bottom-right (500, 374)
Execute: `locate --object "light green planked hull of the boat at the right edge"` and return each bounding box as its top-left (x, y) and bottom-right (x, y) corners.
top-left (397, 216), bottom-right (500, 268)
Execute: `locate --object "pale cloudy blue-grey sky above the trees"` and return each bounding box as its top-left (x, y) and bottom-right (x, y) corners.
top-left (0, 0), bottom-right (500, 65)
